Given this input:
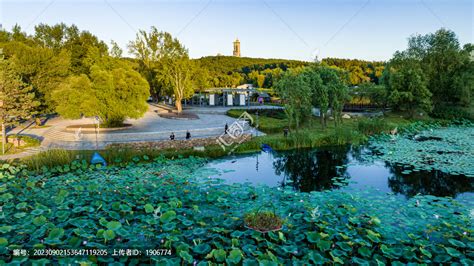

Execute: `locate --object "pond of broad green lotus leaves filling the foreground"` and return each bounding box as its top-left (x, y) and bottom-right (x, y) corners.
top-left (0, 124), bottom-right (474, 265)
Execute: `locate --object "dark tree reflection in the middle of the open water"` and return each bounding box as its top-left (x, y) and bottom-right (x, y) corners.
top-left (273, 146), bottom-right (350, 192)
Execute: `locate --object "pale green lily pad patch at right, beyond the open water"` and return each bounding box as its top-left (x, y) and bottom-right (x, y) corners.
top-left (366, 124), bottom-right (474, 177)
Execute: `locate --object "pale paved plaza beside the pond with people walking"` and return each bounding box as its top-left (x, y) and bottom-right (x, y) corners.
top-left (0, 105), bottom-right (264, 160)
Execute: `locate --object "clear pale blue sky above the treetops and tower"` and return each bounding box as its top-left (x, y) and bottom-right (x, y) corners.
top-left (0, 0), bottom-right (474, 61)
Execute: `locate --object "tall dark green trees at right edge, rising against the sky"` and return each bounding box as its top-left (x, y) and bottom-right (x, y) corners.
top-left (381, 29), bottom-right (474, 118)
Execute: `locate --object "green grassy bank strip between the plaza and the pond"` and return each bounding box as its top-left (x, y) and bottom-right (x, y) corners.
top-left (18, 109), bottom-right (422, 171)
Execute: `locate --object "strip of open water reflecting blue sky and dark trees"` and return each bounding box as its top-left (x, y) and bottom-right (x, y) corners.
top-left (210, 147), bottom-right (474, 198)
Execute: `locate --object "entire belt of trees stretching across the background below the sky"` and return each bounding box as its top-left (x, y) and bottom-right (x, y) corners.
top-left (0, 23), bottom-right (474, 133)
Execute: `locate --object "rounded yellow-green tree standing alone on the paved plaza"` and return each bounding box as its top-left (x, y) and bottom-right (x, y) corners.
top-left (53, 58), bottom-right (150, 127)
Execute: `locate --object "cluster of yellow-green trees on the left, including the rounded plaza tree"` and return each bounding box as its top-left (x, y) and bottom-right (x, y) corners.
top-left (0, 23), bottom-right (149, 126)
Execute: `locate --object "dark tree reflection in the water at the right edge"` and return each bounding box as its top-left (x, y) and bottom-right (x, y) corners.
top-left (387, 164), bottom-right (474, 198)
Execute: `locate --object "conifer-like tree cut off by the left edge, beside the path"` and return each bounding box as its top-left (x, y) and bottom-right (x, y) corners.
top-left (0, 58), bottom-right (39, 153)
